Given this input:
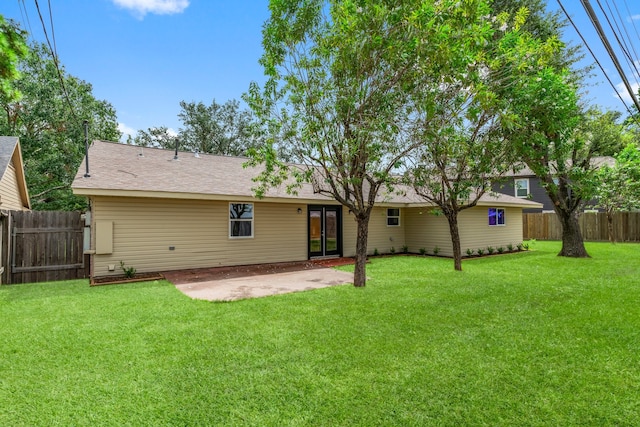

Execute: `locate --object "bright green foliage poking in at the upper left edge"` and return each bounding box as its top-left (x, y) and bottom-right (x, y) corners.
top-left (0, 15), bottom-right (28, 102)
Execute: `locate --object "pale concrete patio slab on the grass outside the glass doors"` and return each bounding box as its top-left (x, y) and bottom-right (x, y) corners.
top-left (175, 267), bottom-right (353, 301)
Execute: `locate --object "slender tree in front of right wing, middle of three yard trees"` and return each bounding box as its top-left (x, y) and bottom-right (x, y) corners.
top-left (407, 5), bottom-right (558, 270)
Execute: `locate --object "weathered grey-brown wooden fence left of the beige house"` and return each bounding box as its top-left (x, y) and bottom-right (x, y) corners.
top-left (2, 211), bottom-right (88, 283)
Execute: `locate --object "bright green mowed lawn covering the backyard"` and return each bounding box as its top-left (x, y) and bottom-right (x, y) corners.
top-left (0, 242), bottom-right (640, 426)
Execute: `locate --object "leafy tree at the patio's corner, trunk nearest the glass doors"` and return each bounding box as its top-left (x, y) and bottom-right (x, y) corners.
top-left (245, 0), bottom-right (504, 286)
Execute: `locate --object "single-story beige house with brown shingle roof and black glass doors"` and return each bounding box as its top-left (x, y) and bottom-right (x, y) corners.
top-left (72, 141), bottom-right (539, 277)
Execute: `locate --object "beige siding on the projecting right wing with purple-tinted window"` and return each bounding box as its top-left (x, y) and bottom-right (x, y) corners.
top-left (404, 206), bottom-right (522, 256)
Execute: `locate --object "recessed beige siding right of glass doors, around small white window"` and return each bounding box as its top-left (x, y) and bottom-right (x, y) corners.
top-left (342, 207), bottom-right (406, 256)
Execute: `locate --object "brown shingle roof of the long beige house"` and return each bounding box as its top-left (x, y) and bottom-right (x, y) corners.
top-left (71, 141), bottom-right (540, 207)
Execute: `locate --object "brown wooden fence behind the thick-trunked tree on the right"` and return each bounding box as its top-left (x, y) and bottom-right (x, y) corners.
top-left (522, 212), bottom-right (640, 242)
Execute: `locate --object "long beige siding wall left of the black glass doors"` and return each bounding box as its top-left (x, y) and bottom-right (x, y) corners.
top-left (92, 197), bottom-right (307, 277)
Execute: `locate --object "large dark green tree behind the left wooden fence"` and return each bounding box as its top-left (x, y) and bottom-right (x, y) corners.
top-left (0, 44), bottom-right (120, 210)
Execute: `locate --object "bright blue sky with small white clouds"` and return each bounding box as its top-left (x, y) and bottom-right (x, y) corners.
top-left (0, 0), bottom-right (640, 141)
